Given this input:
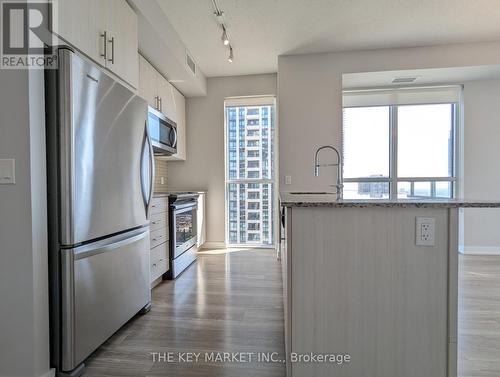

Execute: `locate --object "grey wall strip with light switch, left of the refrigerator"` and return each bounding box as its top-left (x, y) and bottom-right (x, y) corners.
top-left (0, 69), bottom-right (51, 377)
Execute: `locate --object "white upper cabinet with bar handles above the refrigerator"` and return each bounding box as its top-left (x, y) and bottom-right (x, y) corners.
top-left (52, 0), bottom-right (139, 88)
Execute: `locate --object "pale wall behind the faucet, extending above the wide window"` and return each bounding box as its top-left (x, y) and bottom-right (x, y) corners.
top-left (278, 42), bottom-right (500, 191)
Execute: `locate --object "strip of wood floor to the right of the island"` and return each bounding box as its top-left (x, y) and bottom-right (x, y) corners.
top-left (458, 255), bottom-right (500, 377)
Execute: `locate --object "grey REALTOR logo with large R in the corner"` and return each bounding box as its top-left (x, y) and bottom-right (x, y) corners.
top-left (0, 0), bottom-right (57, 69)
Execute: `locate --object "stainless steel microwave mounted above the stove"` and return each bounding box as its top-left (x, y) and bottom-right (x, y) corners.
top-left (148, 107), bottom-right (177, 156)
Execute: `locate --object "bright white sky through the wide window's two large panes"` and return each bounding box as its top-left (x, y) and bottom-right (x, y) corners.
top-left (344, 104), bottom-right (452, 178)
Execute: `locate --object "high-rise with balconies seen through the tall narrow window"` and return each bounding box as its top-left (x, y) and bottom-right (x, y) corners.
top-left (226, 105), bottom-right (274, 245)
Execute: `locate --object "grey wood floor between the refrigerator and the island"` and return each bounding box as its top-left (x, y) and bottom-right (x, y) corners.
top-left (84, 249), bottom-right (285, 377)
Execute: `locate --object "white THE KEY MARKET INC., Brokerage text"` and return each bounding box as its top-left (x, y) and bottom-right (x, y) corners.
top-left (150, 352), bottom-right (351, 366)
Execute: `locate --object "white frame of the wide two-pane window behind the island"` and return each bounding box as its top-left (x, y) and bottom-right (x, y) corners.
top-left (342, 102), bottom-right (461, 200)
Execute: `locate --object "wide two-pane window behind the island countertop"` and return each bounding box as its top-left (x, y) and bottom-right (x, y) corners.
top-left (343, 88), bottom-right (458, 199)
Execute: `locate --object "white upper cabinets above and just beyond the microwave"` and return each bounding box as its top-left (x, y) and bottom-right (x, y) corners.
top-left (138, 55), bottom-right (186, 161)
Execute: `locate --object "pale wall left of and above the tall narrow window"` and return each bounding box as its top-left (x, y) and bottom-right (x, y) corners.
top-left (167, 74), bottom-right (277, 243)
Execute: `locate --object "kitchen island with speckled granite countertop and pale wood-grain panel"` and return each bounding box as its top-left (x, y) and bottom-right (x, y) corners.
top-left (281, 193), bottom-right (500, 377)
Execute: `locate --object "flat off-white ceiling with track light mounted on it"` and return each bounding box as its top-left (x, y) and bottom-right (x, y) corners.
top-left (157, 0), bottom-right (500, 76)
